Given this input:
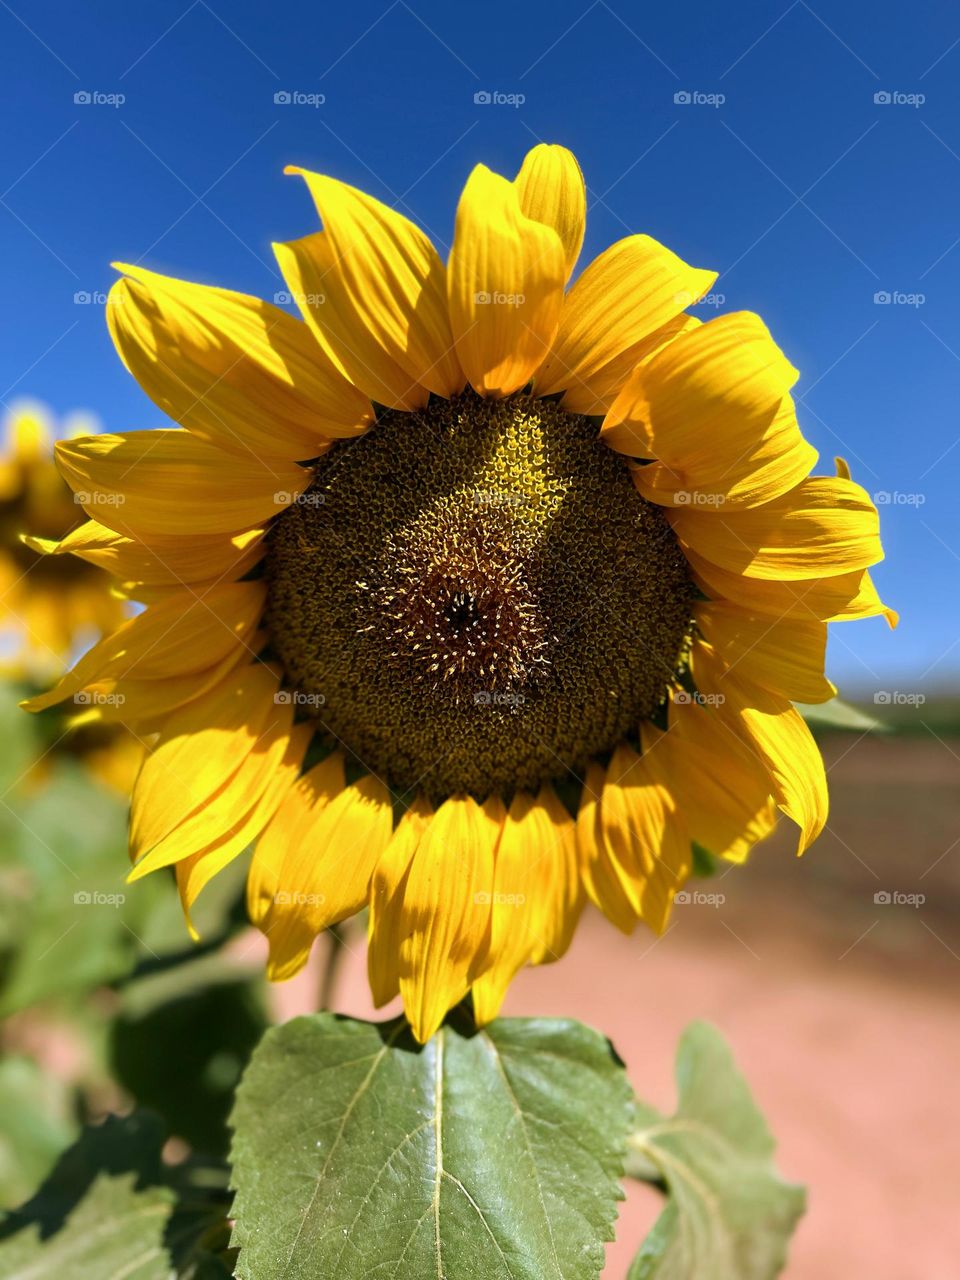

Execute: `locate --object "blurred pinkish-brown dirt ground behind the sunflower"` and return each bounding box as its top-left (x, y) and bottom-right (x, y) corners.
top-left (276, 735), bottom-right (960, 1280)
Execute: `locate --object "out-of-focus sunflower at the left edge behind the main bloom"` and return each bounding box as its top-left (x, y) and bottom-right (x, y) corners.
top-left (0, 401), bottom-right (141, 791)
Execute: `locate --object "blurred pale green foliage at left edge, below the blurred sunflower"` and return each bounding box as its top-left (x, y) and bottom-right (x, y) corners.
top-left (0, 689), bottom-right (244, 1016)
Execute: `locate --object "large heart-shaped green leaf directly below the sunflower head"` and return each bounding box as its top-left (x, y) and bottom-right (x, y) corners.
top-left (225, 1011), bottom-right (631, 1280)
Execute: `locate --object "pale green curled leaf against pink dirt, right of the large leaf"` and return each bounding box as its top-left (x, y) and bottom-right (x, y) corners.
top-left (628, 1023), bottom-right (805, 1280)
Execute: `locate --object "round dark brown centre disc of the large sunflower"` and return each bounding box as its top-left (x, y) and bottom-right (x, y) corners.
top-left (266, 392), bottom-right (694, 801)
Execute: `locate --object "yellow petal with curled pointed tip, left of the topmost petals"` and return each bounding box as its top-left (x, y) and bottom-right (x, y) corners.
top-left (287, 168), bottom-right (465, 399)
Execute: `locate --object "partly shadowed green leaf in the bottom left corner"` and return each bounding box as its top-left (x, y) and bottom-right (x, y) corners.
top-left (0, 1112), bottom-right (234, 1280)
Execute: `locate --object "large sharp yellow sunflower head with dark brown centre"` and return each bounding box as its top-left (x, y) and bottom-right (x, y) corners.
top-left (22, 145), bottom-right (893, 1041)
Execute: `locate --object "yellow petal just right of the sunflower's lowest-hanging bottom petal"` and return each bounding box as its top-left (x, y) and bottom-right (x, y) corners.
top-left (474, 786), bottom-right (582, 1024)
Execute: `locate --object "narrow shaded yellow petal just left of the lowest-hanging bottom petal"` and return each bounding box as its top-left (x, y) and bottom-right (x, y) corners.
top-left (366, 796), bottom-right (434, 1009)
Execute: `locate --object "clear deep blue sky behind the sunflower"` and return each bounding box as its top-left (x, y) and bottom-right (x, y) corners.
top-left (0, 0), bottom-right (960, 690)
